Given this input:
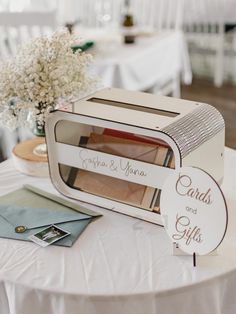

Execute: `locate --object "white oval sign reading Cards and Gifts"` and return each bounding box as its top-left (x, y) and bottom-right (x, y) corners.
top-left (160, 167), bottom-right (228, 255)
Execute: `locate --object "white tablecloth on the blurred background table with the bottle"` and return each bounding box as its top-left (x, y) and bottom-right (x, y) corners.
top-left (86, 31), bottom-right (192, 90)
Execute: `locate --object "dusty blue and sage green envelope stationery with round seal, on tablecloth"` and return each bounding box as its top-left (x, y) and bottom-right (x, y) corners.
top-left (0, 185), bottom-right (101, 247)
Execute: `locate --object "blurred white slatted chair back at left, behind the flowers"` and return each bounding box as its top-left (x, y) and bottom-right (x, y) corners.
top-left (0, 11), bottom-right (57, 60)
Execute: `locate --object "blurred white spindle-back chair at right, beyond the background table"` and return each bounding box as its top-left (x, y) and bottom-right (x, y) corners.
top-left (184, 0), bottom-right (226, 87)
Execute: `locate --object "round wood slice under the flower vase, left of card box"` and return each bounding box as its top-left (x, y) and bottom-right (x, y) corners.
top-left (12, 137), bottom-right (49, 177)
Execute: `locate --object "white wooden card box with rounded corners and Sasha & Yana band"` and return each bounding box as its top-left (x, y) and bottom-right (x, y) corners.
top-left (46, 88), bottom-right (225, 224)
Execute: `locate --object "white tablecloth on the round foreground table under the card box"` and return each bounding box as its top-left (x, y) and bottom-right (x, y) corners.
top-left (0, 149), bottom-right (236, 314)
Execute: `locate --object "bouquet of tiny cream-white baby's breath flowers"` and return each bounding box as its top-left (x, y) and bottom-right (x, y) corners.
top-left (0, 31), bottom-right (95, 129)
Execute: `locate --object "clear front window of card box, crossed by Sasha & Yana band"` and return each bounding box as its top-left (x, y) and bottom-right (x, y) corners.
top-left (55, 120), bottom-right (175, 212)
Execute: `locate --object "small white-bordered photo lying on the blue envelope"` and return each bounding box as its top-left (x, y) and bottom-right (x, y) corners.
top-left (29, 225), bottom-right (70, 247)
